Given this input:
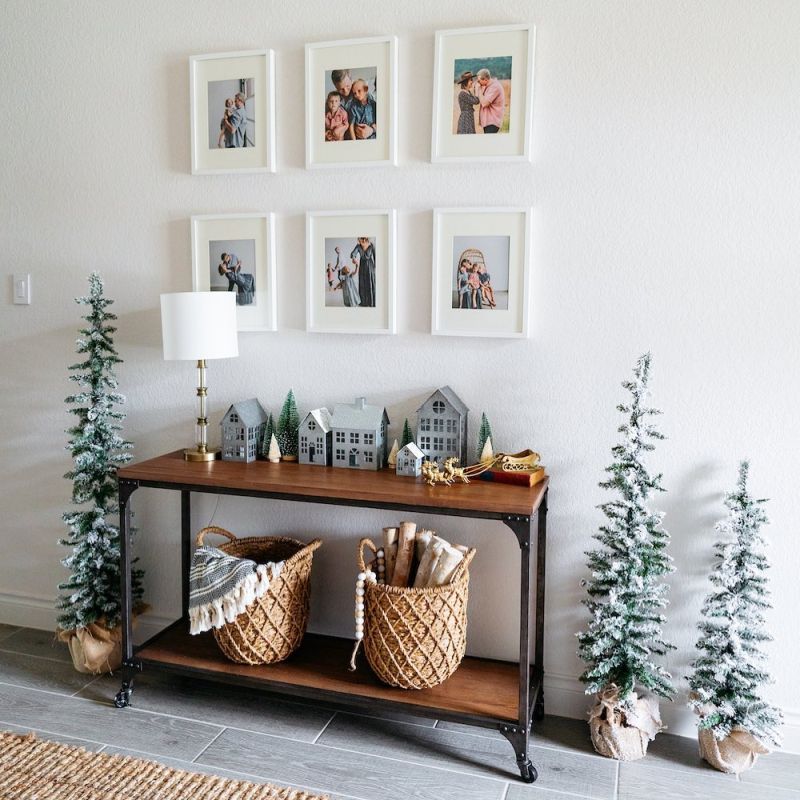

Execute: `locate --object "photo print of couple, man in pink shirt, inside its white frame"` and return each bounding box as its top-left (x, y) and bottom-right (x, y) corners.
top-left (453, 56), bottom-right (512, 134)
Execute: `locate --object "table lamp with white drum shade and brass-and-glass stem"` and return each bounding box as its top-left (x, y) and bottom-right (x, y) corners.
top-left (161, 292), bottom-right (239, 461)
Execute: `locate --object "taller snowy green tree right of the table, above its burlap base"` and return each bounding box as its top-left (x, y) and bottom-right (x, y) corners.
top-left (578, 353), bottom-right (675, 709)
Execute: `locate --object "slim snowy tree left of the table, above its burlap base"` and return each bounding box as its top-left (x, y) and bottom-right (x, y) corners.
top-left (57, 272), bottom-right (142, 631)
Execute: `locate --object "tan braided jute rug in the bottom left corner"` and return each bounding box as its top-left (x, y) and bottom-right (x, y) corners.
top-left (0, 733), bottom-right (326, 800)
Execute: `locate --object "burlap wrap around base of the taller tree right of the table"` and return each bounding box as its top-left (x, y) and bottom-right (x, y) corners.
top-left (589, 686), bottom-right (663, 761)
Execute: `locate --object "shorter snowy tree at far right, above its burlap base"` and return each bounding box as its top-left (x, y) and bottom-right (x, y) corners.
top-left (689, 461), bottom-right (782, 744)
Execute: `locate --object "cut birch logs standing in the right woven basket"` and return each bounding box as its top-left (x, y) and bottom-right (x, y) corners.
top-left (378, 522), bottom-right (469, 589)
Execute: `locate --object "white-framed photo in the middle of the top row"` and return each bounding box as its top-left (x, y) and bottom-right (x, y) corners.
top-left (306, 36), bottom-right (397, 168)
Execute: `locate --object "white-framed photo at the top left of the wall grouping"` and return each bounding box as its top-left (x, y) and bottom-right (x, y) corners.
top-left (189, 50), bottom-right (276, 175)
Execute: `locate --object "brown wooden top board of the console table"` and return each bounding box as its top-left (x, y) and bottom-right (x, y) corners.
top-left (117, 450), bottom-right (549, 519)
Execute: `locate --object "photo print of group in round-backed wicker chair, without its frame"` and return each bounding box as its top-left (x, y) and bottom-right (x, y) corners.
top-left (452, 236), bottom-right (511, 311)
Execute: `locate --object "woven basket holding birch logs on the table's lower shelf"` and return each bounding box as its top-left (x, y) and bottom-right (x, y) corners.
top-left (358, 539), bottom-right (475, 689)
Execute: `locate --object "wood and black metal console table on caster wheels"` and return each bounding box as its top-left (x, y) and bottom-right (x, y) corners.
top-left (114, 451), bottom-right (548, 783)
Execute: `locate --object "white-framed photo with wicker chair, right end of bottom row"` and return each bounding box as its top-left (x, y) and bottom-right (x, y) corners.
top-left (431, 208), bottom-right (530, 338)
